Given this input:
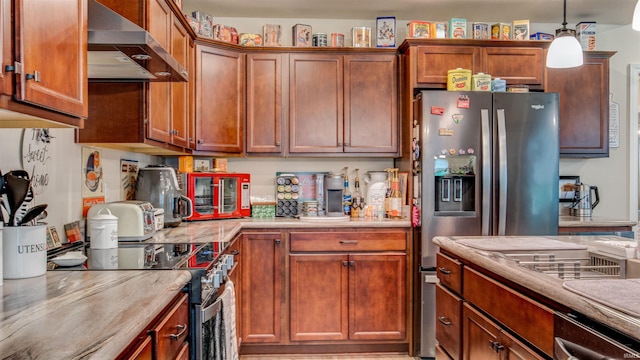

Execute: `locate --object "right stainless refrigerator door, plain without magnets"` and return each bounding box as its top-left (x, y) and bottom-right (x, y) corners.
top-left (492, 92), bottom-right (559, 235)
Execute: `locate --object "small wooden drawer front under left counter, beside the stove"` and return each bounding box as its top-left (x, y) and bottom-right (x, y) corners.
top-left (151, 294), bottom-right (189, 359)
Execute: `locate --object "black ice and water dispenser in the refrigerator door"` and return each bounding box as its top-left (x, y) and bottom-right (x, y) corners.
top-left (434, 155), bottom-right (476, 216)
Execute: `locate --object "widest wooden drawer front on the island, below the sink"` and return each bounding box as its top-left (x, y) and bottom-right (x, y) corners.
top-left (462, 266), bottom-right (554, 356)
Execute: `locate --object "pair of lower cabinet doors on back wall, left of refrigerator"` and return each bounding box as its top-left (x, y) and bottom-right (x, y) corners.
top-left (290, 253), bottom-right (406, 341)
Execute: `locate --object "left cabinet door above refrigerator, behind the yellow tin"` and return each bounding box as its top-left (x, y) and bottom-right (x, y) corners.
top-left (416, 46), bottom-right (481, 88)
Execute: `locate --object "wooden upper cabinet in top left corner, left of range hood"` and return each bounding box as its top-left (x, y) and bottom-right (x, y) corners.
top-left (0, 0), bottom-right (88, 127)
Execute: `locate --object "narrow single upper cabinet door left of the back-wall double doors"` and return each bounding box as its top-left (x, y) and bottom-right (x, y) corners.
top-left (247, 54), bottom-right (283, 153)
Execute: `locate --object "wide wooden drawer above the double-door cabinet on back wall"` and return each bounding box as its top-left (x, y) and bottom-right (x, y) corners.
top-left (290, 230), bottom-right (407, 251)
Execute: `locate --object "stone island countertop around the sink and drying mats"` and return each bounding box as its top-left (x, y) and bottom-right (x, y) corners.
top-left (433, 236), bottom-right (640, 341)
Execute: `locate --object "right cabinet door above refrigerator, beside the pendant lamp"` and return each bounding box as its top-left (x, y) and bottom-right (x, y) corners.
top-left (482, 47), bottom-right (545, 89)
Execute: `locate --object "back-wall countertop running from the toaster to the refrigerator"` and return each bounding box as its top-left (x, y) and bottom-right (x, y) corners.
top-left (150, 217), bottom-right (411, 243)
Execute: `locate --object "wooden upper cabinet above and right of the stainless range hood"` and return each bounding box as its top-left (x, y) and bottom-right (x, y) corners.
top-left (77, 0), bottom-right (195, 155)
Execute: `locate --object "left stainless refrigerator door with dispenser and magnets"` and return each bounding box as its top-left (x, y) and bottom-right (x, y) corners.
top-left (419, 91), bottom-right (492, 268)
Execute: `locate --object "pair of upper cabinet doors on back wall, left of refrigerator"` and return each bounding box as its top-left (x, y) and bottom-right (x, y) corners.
top-left (288, 52), bottom-right (399, 156)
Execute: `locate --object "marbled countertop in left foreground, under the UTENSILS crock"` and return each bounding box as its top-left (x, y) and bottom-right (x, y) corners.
top-left (0, 270), bottom-right (191, 359)
